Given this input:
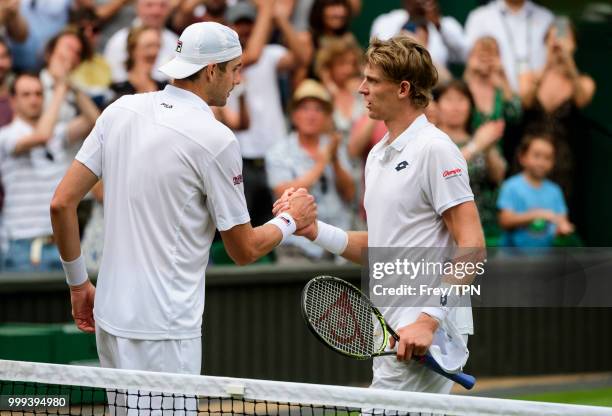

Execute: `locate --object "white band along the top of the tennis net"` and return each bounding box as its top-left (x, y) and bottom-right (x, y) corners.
top-left (0, 358), bottom-right (612, 416)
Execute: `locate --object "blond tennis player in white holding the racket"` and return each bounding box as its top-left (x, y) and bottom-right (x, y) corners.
top-left (275, 36), bottom-right (484, 393)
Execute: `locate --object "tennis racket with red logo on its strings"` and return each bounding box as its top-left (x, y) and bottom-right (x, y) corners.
top-left (302, 276), bottom-right (476, 390)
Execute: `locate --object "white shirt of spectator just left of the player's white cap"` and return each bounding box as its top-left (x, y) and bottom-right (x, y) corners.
top-left (104, 22), bottom-right (178, 82)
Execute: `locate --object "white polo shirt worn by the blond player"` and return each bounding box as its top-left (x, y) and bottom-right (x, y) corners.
top-left (364, 115), bottom-right (474, 333)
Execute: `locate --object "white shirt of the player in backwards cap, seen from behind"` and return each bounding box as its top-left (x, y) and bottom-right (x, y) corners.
top-left (76, 85), bottom-right (250, 340)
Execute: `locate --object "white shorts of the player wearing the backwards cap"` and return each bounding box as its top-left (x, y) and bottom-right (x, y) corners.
top-left (96, 326), bottom-right (202, 416)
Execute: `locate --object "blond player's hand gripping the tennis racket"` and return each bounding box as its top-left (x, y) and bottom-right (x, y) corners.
top-left (390, 313), bottom-right (438, 361)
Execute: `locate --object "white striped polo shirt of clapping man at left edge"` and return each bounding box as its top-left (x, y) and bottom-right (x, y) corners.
top-left (0, 117), bottom-right (67, 241)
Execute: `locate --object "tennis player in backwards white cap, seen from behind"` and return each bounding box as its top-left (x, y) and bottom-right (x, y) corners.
top-left (51, 22), bottom-right (316, 374)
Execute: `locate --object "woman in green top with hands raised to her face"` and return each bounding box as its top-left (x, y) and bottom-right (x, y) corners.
top-left (463, 36), bottom-right (521, 129)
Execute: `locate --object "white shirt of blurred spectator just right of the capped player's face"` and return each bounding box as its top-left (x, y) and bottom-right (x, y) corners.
top-left (228, 45), bottom-right (287, 159)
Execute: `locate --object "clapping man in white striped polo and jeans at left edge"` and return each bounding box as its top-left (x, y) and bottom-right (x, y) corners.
top-left (0, 73), bottom-right (99, 271)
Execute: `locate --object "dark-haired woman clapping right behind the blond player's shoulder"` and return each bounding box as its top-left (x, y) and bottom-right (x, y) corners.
top-left (434, 80), bottom-right (507, 245)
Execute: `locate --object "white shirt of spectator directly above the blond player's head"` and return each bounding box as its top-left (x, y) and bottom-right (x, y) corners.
top-left (370, 9), bottom-right (468, 66)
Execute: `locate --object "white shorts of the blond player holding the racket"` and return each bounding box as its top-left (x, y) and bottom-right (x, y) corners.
top-left (370, 335), bottom-right (468, 394)
